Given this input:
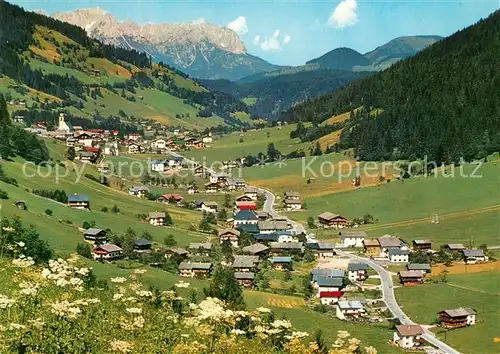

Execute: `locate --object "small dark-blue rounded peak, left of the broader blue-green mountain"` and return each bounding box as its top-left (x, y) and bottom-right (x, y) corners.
top-left (306, 48), bottom-right (370, 71)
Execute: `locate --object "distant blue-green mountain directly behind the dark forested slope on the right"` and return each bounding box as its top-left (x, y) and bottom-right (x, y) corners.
top-left (364, 36), bottom-right (443, 69)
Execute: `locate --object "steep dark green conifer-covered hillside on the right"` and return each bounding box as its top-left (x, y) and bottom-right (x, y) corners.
top-left (282, 11), bottom-right (500, 162)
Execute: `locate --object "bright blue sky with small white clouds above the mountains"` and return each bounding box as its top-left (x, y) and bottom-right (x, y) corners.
top-left (11, 0), bottom-right (500, 65)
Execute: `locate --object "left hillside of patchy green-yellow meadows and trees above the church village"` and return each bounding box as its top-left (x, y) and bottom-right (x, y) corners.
top-left (0, 0), bottom-right (248, 128)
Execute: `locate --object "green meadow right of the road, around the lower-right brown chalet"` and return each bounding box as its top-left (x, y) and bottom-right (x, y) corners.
top-left (395, 271), bottom-right (500, 354)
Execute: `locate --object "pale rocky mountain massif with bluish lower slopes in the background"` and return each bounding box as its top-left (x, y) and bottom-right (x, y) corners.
top-left (52, 8), bottom-right (278, 80)
